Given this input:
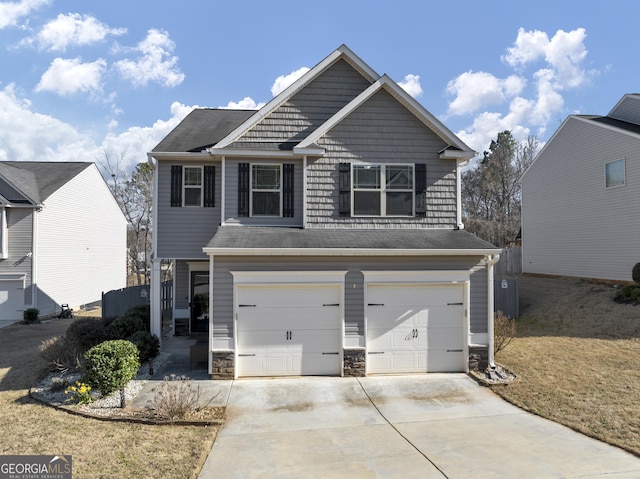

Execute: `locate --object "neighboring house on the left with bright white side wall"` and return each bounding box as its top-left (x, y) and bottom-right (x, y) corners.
top-left (0, 161), bottom-right (127, 326)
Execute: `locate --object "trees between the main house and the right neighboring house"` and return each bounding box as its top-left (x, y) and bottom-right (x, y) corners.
top-left (462, 130), bottom-right (539, 246)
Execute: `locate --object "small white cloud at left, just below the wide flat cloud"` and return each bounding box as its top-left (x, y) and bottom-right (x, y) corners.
top-left (36, 58), bottom-right (107, 96)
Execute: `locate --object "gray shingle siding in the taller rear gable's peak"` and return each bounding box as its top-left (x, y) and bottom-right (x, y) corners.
top-left (232, 60), bottom-right (370, 148)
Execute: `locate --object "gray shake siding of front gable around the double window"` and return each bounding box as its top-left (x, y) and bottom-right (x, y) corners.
top-left (307, 90), bottom-right (457, 228)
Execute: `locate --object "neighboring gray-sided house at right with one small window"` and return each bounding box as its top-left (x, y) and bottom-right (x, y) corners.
top-left (522, 94), bottom-right (640, 281)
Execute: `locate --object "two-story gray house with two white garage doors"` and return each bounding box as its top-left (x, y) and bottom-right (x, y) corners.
top-left (149, 46), bottom-right (499, 378)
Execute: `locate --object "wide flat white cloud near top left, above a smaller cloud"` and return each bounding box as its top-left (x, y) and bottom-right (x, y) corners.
top-left (23, 13), bottom-right (127, 51)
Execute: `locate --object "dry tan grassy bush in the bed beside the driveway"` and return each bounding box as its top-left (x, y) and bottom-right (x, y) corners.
top-left (153, 374), bottom-right (205, 424)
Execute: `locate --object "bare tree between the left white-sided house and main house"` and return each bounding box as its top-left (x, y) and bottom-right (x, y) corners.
top-left (98, 152), bottom-right (153, 285)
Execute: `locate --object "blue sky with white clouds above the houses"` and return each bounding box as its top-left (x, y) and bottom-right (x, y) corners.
top-left (0, 0), bottom-right (640, 172)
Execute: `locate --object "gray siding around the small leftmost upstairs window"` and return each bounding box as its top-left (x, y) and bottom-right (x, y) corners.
top-left (154, 159), bottom-right (222, 259)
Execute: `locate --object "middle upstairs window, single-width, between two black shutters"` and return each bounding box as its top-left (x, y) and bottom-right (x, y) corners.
top-left (251, 164), bottom-right (282, 216)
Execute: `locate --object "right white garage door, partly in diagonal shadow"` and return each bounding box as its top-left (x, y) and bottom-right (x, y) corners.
top-left (367, 284), bottom-right (466, 374)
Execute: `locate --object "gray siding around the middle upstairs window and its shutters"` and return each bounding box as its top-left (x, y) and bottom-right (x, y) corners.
top-left (224, 158), bottom-right (304, 226)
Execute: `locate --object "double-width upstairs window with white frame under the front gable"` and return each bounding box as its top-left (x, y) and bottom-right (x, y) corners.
top-left (352, 164), bottom-right (414, 216)
